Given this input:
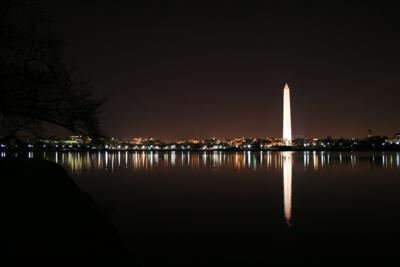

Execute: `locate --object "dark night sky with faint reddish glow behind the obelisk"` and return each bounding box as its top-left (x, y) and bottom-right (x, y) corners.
top-left (39, 1), bottom-right (400, 139)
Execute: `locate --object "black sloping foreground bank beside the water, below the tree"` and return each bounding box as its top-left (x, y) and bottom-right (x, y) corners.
top-left (0, 158), bottom-right (134, 266)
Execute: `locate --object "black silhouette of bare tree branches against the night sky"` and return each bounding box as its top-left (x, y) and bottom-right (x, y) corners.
top-left (0, 1), bottom-right (104, 140)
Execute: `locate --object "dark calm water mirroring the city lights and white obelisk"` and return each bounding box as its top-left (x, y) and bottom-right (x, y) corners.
top-left (5, 151), bottom-right (400, 266)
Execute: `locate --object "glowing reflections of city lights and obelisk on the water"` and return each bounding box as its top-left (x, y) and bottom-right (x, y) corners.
top-left (0, 151), bottom-right (400, 226)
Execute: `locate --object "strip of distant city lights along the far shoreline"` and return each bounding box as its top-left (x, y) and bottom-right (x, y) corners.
top-left (0, 130), bottom-right (400, 151)
